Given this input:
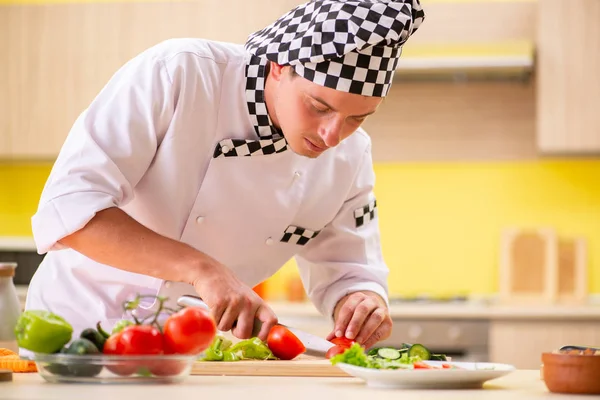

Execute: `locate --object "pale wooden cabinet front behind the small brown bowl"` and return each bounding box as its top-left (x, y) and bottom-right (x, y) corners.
top-left (490, 321), bottom-right (600, 369)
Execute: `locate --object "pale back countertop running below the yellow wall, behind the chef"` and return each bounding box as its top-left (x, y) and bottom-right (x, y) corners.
top-left (16, 285), bottom-right (600, 322)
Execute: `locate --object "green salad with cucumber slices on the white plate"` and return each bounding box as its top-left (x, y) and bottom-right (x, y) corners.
top-left (331, 343), bottom-right (449, 369)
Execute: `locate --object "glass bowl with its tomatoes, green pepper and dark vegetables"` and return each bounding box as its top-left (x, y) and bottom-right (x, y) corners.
top-left (15, 296), bottom-right (217, 383)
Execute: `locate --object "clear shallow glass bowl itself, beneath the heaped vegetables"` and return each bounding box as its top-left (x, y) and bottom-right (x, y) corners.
top-left (29, 353), bottom-right (201, 383)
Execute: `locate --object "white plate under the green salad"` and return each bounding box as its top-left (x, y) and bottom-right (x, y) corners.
top-left (336, 361), bottom-right (515, 389)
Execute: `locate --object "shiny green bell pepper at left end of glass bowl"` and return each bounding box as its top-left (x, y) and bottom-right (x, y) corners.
top-left (14, 310), bottom-right (73, 353)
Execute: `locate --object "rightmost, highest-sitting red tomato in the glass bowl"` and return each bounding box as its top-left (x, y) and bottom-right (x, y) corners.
top-left (163, 307), bottom-right (217, 354)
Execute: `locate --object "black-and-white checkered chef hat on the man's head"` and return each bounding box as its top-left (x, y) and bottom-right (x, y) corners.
top-left (245, 0), bottom-right (425, 97)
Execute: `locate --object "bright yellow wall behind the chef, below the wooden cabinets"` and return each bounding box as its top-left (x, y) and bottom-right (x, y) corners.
top-left (0, 160), bottom-right (600, 297)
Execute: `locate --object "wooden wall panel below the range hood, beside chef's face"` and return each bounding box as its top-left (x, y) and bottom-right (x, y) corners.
top-left (364, 82), bottom-right (537, 162)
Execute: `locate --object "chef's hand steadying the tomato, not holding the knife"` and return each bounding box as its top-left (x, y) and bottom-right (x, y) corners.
top-left (327, 291), bottom-right (392, 349)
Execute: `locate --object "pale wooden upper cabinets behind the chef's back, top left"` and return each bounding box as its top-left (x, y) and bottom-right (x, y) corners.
top-left (0, 0), bottom-right (308, 158)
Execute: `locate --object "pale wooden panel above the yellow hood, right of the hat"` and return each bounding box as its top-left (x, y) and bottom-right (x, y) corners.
top-left (409, 0), bottom-right (536, 46)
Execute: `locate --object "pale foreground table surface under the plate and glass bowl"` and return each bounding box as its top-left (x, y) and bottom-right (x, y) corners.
top-left (0, 370), bottom-right (555, 400)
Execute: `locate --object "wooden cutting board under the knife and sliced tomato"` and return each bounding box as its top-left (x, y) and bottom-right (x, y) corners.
top-left (191, 359), bottom-right (349, 377)
